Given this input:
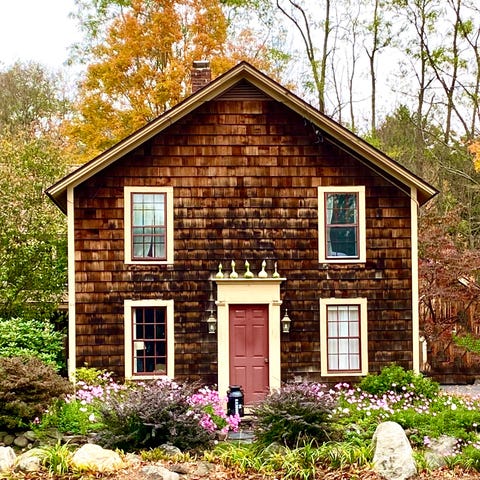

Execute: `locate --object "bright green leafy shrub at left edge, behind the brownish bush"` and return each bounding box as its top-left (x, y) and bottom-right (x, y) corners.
top-left (0, 318), bottom-right (65, 371)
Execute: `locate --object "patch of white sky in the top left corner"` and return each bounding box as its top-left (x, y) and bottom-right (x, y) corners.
top-left (0, 0), bottom-right (80, 69)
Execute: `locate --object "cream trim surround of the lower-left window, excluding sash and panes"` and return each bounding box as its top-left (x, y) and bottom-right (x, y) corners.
top-left (123, 299), bottom-right (175, 380)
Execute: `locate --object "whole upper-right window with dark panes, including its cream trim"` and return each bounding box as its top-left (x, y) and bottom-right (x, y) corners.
top-left (318, 186), bottom-right (366, 263)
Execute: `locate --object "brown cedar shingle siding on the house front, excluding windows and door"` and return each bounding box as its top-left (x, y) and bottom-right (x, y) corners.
top-left (70, 83), bottom-right (413, 384)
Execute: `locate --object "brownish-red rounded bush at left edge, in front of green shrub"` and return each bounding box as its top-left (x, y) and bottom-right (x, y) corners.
top-left (0, 357), bottom-right (72, 428)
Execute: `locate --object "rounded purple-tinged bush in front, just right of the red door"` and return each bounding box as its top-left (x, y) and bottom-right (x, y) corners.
top-left (252, 382), bottom-right (338, 448)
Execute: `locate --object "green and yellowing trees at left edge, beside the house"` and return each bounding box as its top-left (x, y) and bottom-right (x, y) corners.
top-left (0, 64), bottom-right (66, 319)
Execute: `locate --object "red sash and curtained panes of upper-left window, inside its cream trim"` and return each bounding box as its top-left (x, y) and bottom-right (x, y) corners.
top-left (131, 193), bottom-right (167, 260)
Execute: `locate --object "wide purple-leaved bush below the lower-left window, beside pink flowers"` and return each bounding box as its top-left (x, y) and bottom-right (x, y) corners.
top-left (99, 379), bottom-right (213, 451)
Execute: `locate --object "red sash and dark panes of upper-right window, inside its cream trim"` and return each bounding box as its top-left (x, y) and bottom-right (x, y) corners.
top-left (325, 193), bottom-right (358, 258)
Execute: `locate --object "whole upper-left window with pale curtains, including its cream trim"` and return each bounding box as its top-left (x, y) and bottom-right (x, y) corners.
top-left (125, 187), bottom-right (173, 263)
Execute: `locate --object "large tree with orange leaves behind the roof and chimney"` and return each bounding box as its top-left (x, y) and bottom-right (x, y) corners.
top-left (65, 0), bottom-right (286, 162)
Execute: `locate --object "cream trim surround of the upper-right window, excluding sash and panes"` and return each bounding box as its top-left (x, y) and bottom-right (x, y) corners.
top-left (318, 185), bottom-right (367, 263)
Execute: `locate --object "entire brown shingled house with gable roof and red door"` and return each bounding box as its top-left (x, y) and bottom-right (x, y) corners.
top-left (47, 63), bottom-right (436, 403)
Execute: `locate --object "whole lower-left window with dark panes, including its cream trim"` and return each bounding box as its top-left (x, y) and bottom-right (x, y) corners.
top-left (125, 300), bottom-right (174, 378)
